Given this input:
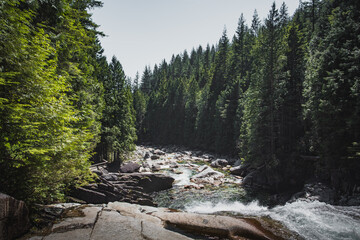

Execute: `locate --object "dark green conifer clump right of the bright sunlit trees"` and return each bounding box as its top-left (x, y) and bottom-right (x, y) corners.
top-left (97, 57), bottom-right (136, 162)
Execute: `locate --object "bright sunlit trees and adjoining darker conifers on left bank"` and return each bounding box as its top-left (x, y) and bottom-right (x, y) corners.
top-left (0, 0), bottom-right (136, 203)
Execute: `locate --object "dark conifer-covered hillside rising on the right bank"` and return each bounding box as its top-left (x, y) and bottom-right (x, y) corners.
top-left (134, 0), bottom-right (360, 193)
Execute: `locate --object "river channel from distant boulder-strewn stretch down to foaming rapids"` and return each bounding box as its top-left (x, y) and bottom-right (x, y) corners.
top-left (132, 146), bottom-right (360, 240)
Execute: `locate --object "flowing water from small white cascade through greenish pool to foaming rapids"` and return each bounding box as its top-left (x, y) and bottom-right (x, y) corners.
top-left (155, 161), bottom-right (360, 240)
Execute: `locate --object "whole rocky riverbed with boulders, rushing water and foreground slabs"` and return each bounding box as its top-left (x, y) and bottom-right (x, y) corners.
top-left (14, 146), bottom-right (360, 240)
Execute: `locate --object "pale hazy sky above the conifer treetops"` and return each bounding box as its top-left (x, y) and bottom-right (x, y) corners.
top-left (92, 0), bottom-right (299, 78)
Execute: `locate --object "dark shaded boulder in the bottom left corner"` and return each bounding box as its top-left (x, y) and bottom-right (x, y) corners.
top-left (0, 193), bottom-right (30, 239)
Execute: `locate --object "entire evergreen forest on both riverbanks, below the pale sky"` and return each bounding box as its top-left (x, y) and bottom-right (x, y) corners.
top-left (0, 0), bottom-right (360, 207)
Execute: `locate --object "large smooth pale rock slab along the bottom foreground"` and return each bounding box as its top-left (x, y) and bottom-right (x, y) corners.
top-left (28, 202), bottom-right (288, 240)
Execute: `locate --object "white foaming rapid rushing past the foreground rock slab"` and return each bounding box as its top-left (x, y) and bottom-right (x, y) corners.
top-left (185, 200), bottom-right (360, 240)
